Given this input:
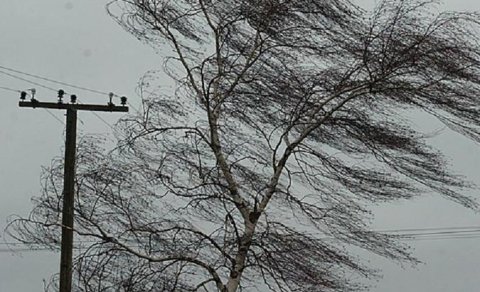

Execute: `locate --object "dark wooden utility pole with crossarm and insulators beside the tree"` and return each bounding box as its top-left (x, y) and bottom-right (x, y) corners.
top-left (18, 90), bottom-right (128, 292)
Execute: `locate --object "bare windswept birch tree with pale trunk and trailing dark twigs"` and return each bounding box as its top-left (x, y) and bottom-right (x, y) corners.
top-left (8, 0), bottom-right (480, 292)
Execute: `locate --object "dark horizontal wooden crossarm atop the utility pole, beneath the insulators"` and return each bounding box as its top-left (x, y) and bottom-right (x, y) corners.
top-left (18, 100), bottom-right (128, 112)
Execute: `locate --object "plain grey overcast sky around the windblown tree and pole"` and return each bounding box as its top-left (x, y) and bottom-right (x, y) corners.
top-left (0, 0), bottom-right (480, 292)
